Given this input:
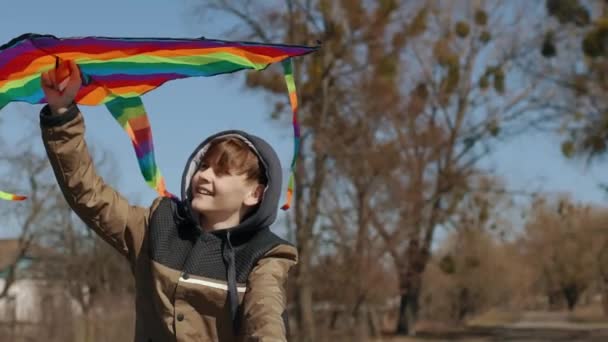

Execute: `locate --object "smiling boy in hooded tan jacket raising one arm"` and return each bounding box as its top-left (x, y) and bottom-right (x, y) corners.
top-left (40, 62), bottom-right (297, 342)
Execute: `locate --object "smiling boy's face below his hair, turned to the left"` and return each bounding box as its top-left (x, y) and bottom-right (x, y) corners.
top-left (191, 164), bottom-right (263, 228)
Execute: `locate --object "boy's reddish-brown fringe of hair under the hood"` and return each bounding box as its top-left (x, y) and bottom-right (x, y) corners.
top-left (201, 137), bottom-right (268, 185)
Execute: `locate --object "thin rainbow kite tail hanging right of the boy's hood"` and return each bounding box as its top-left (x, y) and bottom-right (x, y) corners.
top-left (281, 58), bottom-right (300, 210)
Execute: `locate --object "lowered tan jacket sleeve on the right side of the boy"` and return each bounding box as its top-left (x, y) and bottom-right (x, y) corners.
top-left (243, 245), bottom-right (298, 342)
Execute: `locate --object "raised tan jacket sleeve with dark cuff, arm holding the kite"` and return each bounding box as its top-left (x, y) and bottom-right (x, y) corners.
top-left (40, 105), bottom-right (150, 263)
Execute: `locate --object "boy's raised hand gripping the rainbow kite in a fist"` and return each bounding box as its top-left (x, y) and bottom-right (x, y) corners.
top-left (41, 60), bottom-right (82, 114)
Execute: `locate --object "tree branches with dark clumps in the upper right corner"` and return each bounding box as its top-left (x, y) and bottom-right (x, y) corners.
top-left (532, 0), bottom-right (608, 161)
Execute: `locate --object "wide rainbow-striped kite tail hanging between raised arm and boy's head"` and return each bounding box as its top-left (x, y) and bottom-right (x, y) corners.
top-left (106, 97), bottom-right (175, 197)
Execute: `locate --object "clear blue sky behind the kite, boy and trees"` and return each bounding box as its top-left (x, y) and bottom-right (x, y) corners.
top-left (0, 0), bottom-right (608, 239)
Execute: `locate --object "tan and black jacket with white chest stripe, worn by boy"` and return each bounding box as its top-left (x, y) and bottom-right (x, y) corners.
top-left (41, 106), bottom-right (297, 342)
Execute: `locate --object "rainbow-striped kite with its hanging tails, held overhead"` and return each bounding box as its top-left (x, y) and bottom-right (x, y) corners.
top-left (0, 33), bottom-right (318, 210)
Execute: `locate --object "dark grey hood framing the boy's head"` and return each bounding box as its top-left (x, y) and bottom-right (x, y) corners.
top-left (181, 130), bottom-right (283, 232)
